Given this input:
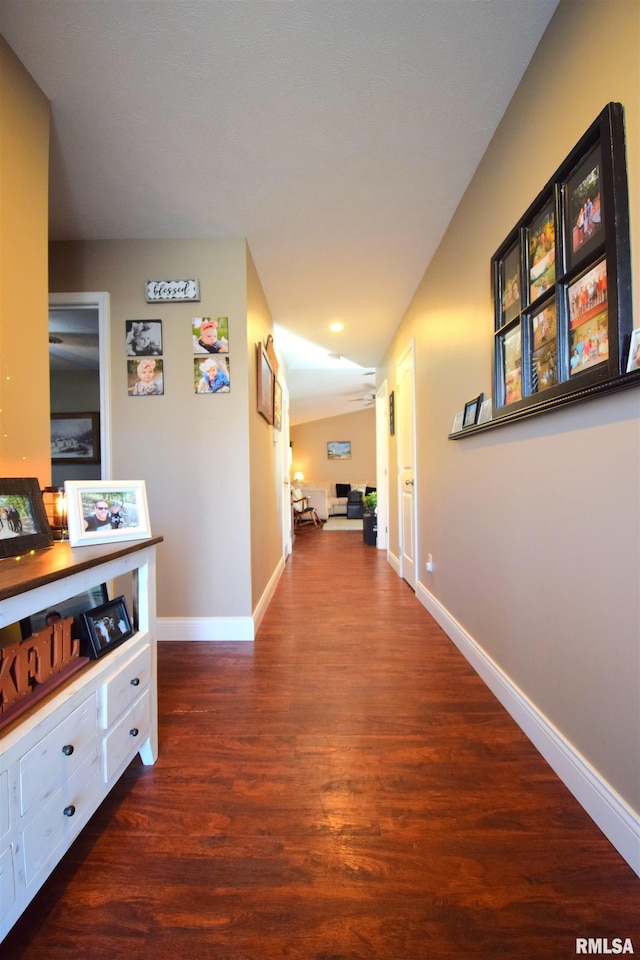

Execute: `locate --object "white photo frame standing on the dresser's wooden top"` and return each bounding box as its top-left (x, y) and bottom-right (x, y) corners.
top-left (64, 480), bottom-right (151, 547)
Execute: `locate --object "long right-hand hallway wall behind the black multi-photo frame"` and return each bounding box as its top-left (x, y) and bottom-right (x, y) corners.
top-left (382, 0), bottom-right (640, 811)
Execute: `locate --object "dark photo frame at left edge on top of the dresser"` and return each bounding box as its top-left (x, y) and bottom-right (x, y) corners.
top-left (0, 477), bottom-right (53, 558)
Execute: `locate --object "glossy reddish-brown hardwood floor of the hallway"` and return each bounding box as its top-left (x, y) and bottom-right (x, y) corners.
top-left (0, 527), bottom-right (640, 960)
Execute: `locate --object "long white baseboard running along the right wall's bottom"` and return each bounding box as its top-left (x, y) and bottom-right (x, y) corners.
top-left (416, 576), bottom-right (640, 876)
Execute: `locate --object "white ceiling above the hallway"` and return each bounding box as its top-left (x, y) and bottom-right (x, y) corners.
top-left (0, 0), bottom-right (558, 424)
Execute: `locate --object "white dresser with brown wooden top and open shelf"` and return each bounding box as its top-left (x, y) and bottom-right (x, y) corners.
top-left (0, 537), bottom-right (162, 940)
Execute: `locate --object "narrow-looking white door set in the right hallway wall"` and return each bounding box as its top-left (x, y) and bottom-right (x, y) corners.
top-left (396, 341), bottom-right (417, 590)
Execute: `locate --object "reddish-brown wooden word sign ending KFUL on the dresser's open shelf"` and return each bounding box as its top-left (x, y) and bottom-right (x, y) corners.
top-left (0, 617), bottom-right (80, 714)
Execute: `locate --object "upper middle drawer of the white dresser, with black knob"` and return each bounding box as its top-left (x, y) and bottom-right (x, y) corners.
top-left (20, 694), bottom-right (98, 816)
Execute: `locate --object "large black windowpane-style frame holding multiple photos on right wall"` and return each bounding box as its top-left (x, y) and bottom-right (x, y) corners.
top-left (491, 103), bottom-right (640, 422)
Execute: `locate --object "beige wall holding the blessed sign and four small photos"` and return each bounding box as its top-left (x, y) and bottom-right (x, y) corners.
top-left (50, 239), bottom-right (279, 618)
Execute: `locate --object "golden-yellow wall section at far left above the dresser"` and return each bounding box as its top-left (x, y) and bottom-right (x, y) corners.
top-left (0, 37), bottom-right (51, 487)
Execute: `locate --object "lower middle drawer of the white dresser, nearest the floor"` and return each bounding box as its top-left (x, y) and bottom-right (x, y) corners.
top-left (22, 747), bottom-right (99, 884)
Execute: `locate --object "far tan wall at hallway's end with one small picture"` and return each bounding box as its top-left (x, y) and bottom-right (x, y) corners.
top-left (291, 407), bottom-right (376, 486)
